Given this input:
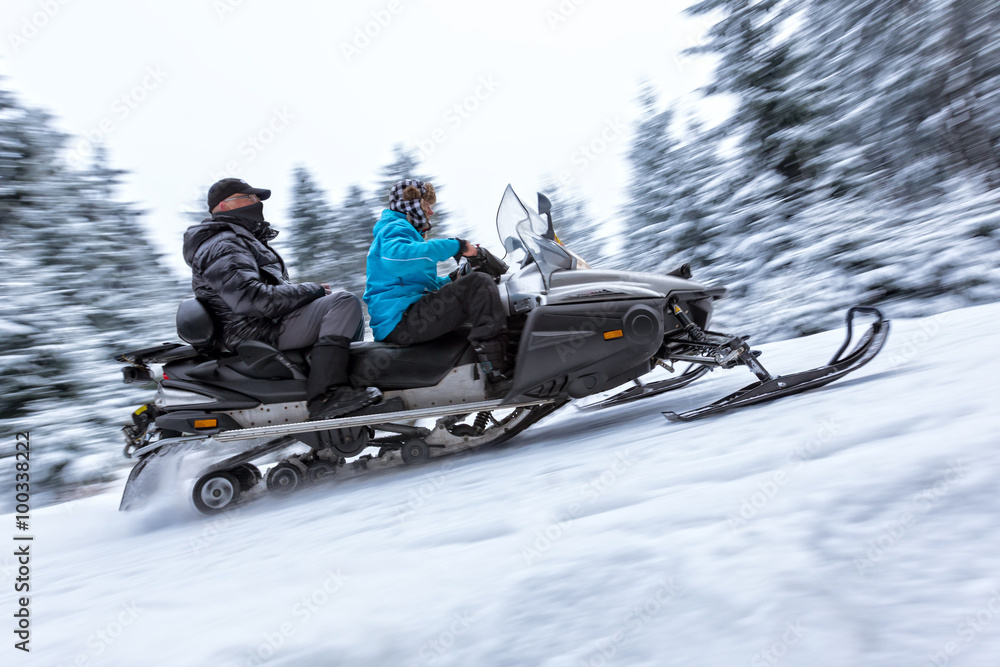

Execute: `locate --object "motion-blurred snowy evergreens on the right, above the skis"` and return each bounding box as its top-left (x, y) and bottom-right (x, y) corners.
top-left (616, 0), bottom-right (1000, 338)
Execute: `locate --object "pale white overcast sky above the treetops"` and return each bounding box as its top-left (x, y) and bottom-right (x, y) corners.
top-left (0, 0), bottom-right (724, 272)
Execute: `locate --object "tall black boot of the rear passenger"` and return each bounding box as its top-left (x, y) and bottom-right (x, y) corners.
top-left (306, 336), bottom-right (382, 420)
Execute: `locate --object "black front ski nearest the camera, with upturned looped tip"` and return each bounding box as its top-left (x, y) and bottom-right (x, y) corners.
top-left (663, 306), bottom-right (889, 422)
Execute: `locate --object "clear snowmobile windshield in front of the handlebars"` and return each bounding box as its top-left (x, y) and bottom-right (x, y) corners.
top-left (497, 185), bottom-right (576, 285)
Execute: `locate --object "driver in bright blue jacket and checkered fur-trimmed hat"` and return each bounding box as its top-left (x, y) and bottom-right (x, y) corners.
top-left (364, 178), bottom-right (510, 381)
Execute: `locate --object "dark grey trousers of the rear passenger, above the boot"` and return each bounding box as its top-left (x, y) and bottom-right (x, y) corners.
top-left (278, 291), bottom-right (364, 350)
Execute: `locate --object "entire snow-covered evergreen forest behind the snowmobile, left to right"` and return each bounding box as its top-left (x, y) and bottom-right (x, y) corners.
top-left (0, 0), bottom-right (1000, 500)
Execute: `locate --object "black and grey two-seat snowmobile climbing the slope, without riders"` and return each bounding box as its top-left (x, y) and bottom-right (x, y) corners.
top-left (117, 186), bottom-right (889, 514)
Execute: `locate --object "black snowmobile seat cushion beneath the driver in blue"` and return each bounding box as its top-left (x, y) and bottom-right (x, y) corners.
top-left (350, 328), bottom-right (475, 391)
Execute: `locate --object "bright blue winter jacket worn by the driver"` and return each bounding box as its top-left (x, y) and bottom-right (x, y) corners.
top-left (365, 209), bottom-right (460, 340)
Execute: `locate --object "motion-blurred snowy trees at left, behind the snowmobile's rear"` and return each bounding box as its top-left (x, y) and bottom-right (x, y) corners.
top-left (0, 82), bottom-right (178, 499)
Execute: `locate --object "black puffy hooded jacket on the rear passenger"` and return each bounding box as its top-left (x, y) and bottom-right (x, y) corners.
top-left (184, 214), bottom-right (326, 351)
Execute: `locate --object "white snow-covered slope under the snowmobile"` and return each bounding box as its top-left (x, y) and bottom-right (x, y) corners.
top-left (0, 305), bottom-right (1000, 667)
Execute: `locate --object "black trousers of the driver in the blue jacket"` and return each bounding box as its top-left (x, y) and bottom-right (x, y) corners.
top-left (385, 272), bottom-right (507, 345)
